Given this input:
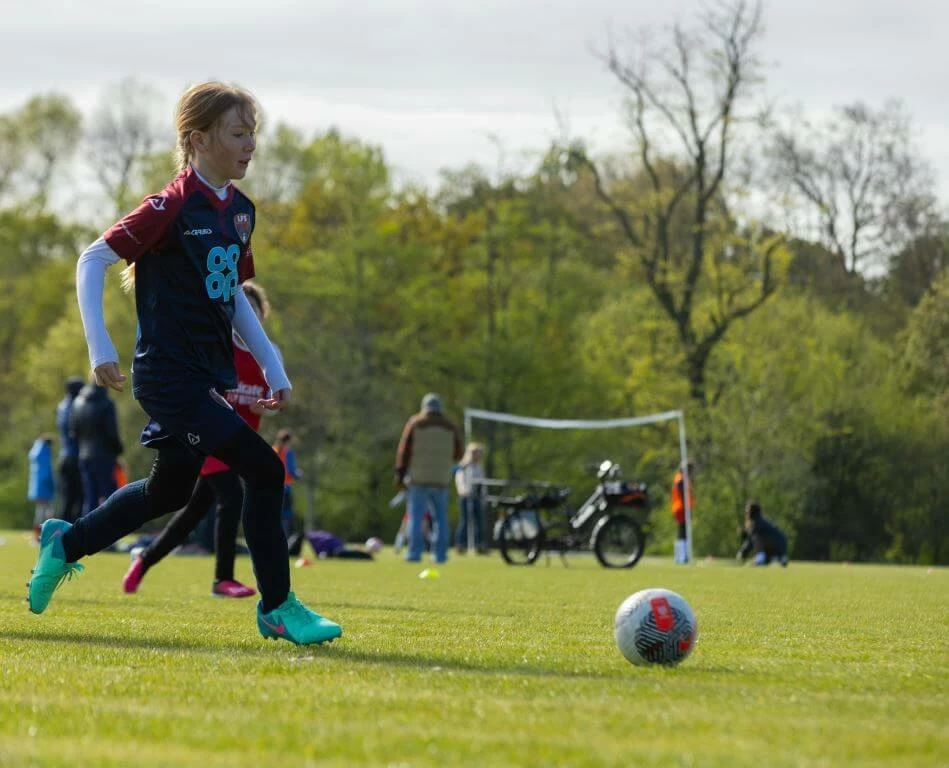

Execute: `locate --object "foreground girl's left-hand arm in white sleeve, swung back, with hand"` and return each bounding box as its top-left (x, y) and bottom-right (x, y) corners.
top-left (76, 237), bottom-right (125, 391)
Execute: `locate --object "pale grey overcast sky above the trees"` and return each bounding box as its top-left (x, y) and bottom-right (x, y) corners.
top-left (0, 0), bottom-right (949, 201)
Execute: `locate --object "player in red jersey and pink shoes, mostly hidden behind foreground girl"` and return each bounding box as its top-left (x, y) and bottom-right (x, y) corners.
top-left (122, 281), bottom-right (270, 597)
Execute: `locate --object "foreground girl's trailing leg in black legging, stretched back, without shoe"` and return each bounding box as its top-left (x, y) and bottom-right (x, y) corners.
top-left (62, 438), bottom-right (202, 563)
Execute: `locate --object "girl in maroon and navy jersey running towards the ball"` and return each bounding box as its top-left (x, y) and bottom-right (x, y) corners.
top-left (29, 82), bottom-right (342, 644)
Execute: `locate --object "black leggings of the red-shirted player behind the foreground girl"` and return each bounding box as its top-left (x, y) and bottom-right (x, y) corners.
top-left (141, 470), bottom-right (244, 581)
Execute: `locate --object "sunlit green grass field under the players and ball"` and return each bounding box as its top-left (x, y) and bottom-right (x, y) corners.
top-left (0, 532), bottom-right (949, 768)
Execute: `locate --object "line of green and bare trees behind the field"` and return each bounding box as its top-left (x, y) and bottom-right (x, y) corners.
top-left (0, 2), bottom-right (949, 563)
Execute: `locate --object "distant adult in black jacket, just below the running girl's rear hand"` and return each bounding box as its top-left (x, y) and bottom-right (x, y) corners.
top-left (69, 382), bottom-right (123, 515)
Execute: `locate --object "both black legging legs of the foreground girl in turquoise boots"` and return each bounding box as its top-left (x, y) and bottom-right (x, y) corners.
top-left (63, 424), bottom-right (290, 612)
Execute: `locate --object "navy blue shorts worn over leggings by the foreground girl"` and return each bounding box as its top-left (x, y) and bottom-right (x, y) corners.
top-left (138, 386), bottom-right (245, 456)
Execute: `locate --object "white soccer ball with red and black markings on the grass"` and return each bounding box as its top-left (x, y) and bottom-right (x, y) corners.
top-left (613, 589), bottom-right (699, 667)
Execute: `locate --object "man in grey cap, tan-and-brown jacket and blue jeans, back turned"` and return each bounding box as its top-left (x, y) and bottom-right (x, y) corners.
top-left (395, 392), bottom-right (462, 563)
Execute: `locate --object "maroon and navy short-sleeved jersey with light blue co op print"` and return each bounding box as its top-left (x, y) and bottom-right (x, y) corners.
top-left (104, 166), bottom-right (254, 396)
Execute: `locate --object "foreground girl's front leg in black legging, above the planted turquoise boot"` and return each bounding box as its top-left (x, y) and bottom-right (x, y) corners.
top-left (214, 424), bottom-right (290, 613)
